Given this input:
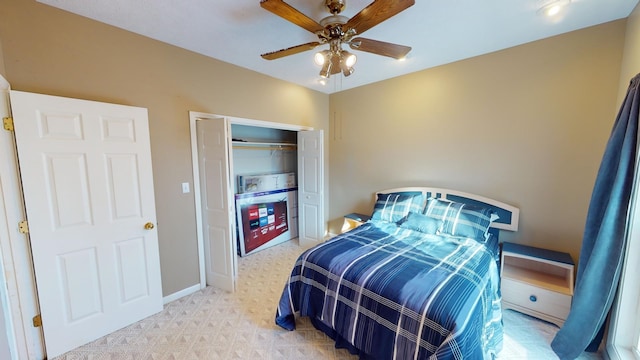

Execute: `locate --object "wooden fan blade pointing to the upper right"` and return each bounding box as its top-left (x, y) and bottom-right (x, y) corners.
top-left (343, 0), bottom-right (415, 34)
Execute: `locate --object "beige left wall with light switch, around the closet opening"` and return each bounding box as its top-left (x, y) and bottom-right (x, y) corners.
top-left (0, 0), bottom-right (329, 295)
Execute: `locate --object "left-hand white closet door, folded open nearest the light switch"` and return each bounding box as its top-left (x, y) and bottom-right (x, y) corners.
top-left (196, 118), bottom-right (236, 292)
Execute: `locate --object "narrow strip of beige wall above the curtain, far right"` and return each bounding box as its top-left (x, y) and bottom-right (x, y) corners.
top-left (618, 4), bottom-right (640, 100)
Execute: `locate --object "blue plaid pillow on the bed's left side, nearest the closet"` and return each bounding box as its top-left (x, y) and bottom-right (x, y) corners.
top-left (371, 193), bottom-right (424, 222)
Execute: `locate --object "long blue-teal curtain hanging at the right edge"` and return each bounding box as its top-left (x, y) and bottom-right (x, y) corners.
top-left (551, 74), bottom-right (640, 360)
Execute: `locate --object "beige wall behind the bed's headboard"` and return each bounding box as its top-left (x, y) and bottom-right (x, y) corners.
top-left (329, 20), bottom-right (637, 260)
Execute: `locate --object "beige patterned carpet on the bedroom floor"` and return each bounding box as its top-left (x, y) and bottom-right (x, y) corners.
top-left (56, 240), bottom-right (602, 360)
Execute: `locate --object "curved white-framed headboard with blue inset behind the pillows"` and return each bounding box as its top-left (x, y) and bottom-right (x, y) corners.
top-left (374, 187), bottom-right (520, 236)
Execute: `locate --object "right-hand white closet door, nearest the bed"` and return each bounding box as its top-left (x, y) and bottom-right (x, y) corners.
top-left (298, 130), bottom-right (325, 247)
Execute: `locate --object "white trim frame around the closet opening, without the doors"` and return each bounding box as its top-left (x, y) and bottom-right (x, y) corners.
top-left (189, 111), bottom-right (312, 289)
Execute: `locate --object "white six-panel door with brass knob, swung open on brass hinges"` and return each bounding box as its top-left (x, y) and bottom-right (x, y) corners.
top-left (10, 91), bottom-right (162, 358)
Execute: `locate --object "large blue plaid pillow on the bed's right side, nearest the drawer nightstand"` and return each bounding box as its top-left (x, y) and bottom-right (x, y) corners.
top-left (424, 198), bottom-right (497, 242)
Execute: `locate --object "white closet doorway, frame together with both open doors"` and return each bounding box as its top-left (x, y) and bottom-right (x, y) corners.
top-left (189, 112), bottom-right (325, 292)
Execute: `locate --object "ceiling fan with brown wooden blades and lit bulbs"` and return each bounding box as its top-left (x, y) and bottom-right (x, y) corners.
top-left (260, 0), bottom-right (415, 78)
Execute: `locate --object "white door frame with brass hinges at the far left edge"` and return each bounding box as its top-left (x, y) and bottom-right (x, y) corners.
top-left (0, 75), bottom-right (45, 359)
